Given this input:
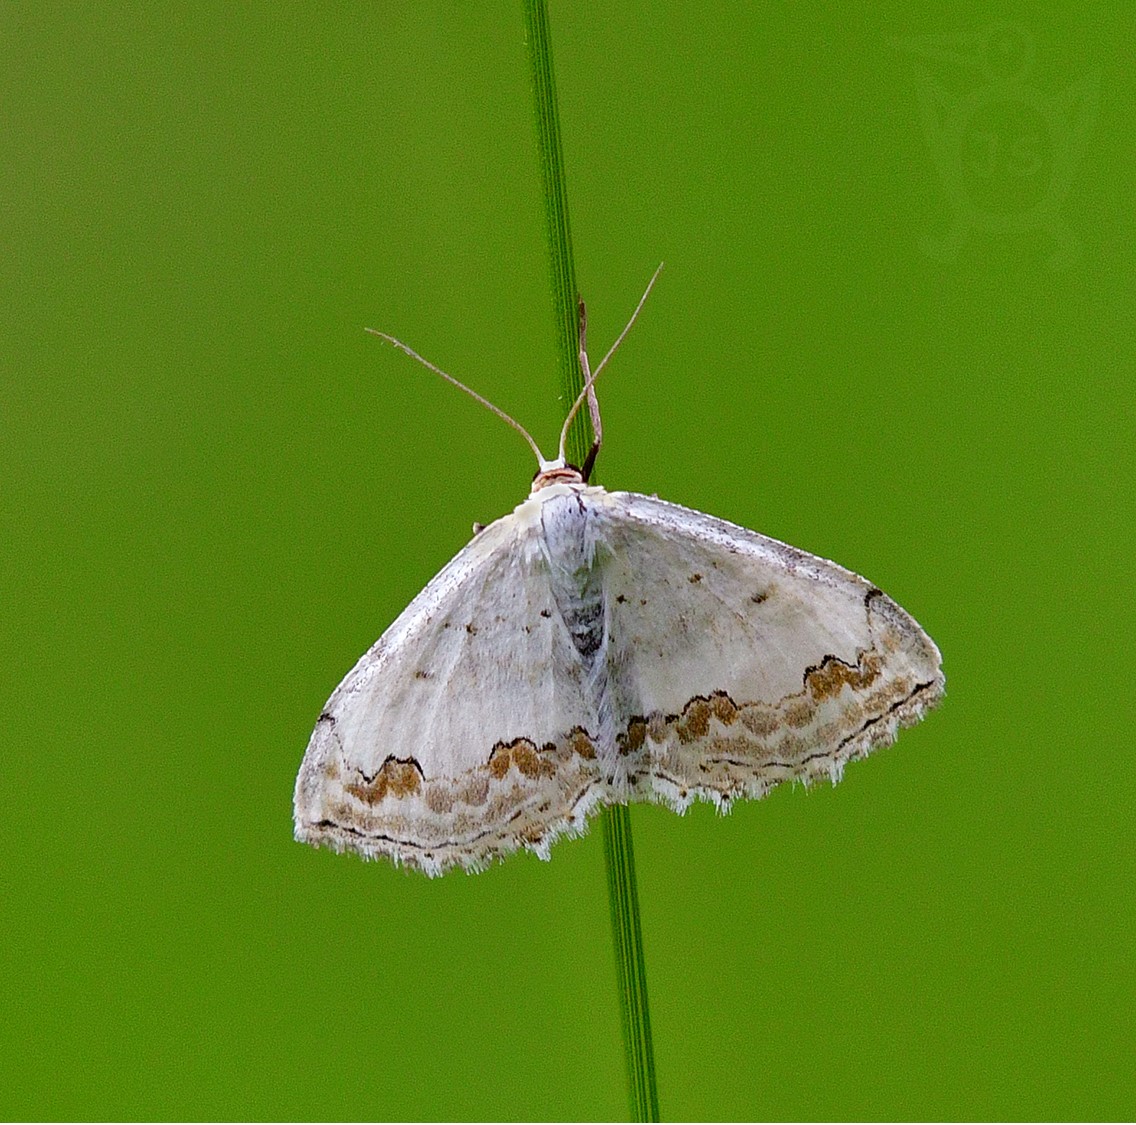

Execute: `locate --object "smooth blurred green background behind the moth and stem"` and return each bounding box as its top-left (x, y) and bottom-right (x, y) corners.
top-left (0, 0), bottom-right (1136, 1119)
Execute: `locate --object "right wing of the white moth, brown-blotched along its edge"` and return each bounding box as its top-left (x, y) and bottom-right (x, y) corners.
top-left (598, 492), bottom-right (944, 809)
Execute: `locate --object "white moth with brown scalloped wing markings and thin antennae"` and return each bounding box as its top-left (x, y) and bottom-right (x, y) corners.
top-left (295, 272), bottom-right (944, 875)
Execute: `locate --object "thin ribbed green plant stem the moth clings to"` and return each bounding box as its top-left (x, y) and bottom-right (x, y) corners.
top-left (524, 0), bottom-right (659, 1122)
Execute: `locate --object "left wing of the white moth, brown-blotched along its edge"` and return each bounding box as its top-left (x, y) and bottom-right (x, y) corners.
top-left (295, 503), bottom-right (604, 874)
